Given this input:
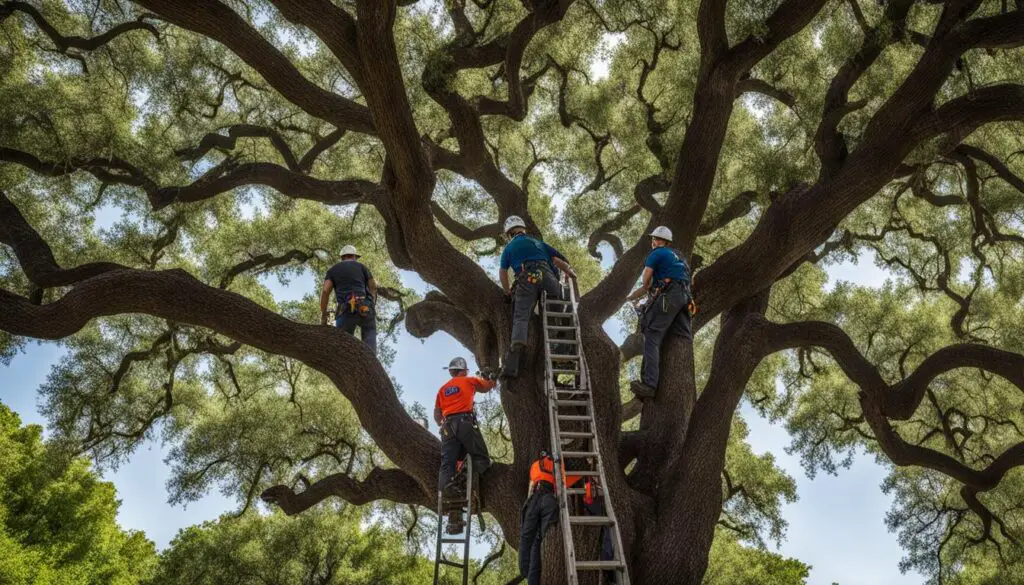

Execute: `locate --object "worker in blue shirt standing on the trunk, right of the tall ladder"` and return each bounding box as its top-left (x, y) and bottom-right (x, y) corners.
top-left (626, 225), bottom-right (692, 399)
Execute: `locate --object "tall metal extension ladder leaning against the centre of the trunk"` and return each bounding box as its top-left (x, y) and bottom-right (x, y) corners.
top-left (541, 283), bottom-right (630, 585)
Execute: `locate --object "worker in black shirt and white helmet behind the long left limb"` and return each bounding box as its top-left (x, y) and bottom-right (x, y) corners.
top-left (321, 245), bottom-right (377, 353)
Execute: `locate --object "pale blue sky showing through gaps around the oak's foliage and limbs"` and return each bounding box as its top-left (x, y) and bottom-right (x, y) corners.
top-left (0, 252), bottom-right (923, 585)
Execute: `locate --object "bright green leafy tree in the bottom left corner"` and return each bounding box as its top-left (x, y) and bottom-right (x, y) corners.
top-left (0, 404), bottom-right (157, 585)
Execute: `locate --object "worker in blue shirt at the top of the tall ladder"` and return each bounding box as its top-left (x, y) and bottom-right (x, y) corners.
top-left (498, 215), bottom-right (577, 378)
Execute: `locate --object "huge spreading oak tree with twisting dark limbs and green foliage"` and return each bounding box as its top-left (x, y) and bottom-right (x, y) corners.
top-left (0, 0), bottom-right (1024, 584)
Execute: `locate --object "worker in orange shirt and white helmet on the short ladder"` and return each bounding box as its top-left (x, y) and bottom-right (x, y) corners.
top-left (434, 358), bottom-right (497, 534)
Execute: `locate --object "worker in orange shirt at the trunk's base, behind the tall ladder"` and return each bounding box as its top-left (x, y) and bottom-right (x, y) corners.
top-left (519, 451), bottom-right (583, 585)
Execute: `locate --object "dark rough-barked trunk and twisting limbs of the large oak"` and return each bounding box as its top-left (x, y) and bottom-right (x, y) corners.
top-left (0, 0), bottom-right (1024, 585)
